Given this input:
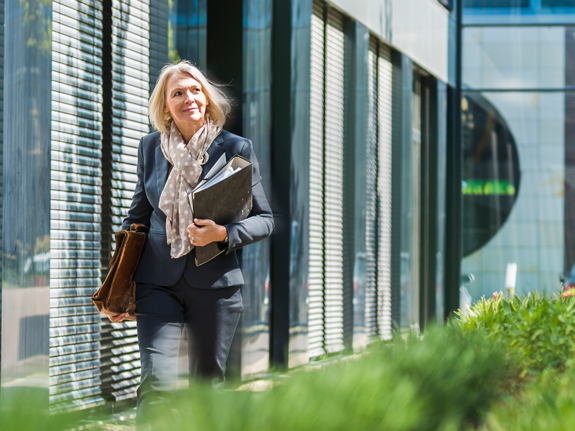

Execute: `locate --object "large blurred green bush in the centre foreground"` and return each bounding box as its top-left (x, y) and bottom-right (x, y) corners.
top-left (151, 328), bottom-right (510, 431)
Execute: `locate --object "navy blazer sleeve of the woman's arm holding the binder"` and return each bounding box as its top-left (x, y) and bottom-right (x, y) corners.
top-left (225, 140), bottom-right (275, 254)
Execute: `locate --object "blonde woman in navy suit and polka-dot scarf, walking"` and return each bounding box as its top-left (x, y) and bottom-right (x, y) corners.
top-left (110, 61), bottom-right (274, 423)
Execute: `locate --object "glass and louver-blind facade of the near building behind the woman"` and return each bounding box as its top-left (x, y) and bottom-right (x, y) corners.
top-left (0, 0), bottom-right (460, 410)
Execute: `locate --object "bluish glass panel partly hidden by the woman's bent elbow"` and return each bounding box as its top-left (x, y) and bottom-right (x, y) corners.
top-left (239, 0), bottom-right (272, 378)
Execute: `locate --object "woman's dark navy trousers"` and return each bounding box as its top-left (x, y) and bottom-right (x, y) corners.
top-left (136, 277), bottom-right (243, 425)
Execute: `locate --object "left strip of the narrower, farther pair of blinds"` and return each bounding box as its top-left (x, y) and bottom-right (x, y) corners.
top-left (365, 39), bottom-right (378, 339)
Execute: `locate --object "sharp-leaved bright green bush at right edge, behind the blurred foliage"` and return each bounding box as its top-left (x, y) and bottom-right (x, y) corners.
top-left (451, 292), bottom-right (575, 373)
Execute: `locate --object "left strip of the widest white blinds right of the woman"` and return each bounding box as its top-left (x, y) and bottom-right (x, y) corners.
top-left (308, 2), bottom-right (325, 358)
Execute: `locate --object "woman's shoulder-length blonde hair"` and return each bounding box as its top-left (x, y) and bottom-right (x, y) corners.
top-left (148, 60), bottom-right (231, 133)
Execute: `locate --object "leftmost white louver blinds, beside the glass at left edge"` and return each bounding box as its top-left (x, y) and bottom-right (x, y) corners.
top-left (50, 0), bottom-right (104, 410)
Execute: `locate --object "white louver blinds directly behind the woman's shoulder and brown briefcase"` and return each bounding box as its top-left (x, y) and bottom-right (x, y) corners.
top-left (102, 0), bottom-right (150, 401)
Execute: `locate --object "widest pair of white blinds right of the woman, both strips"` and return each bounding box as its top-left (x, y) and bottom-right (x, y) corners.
top-left (308, 1), bottom-right (344, 357)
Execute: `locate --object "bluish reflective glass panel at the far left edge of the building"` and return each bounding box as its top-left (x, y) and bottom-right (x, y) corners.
top-left (1, 0), bottom-right (52, 394)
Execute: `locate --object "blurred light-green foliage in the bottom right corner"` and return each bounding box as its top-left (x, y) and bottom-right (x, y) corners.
top-left (480, 369), bottom-right (575, 431)
